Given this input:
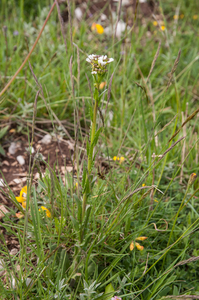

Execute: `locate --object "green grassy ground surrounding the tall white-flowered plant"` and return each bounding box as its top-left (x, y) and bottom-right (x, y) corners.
top-left (0, 1), bottom-right (199, 300)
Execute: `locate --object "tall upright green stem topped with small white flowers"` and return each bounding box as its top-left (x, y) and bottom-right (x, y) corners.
top-left (82, 54), bottom-right (114, 220)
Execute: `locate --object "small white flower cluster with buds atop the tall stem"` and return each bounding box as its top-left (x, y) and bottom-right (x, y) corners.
top-left (86, 54), bottom-right (114, 74)
